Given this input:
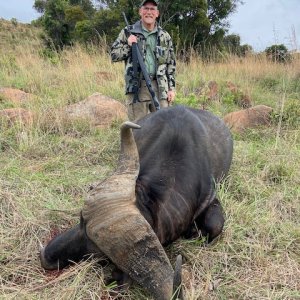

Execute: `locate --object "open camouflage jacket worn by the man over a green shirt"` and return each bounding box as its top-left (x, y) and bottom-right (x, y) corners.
top-left (111, 21), bottom-right (176, 100)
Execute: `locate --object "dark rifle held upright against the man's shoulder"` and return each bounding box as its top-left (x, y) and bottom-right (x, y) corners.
top-left (122, 12), bottom-right (160, 110)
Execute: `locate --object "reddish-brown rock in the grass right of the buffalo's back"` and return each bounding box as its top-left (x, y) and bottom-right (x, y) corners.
top-left (224, 105), bottom-right (273, 133)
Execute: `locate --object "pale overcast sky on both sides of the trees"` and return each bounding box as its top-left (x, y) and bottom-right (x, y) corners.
top-left (0, 0), bottom-right (300, 51)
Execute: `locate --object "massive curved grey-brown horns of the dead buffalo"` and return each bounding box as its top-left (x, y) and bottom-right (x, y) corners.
top-left (82, 122), bottom-right (174, 300)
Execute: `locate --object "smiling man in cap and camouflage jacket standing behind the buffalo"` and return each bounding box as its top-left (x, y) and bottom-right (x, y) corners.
top-left (111, 0), bottom-right (176, 121)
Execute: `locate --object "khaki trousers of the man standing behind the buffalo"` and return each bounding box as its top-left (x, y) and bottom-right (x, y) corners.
top-left (126, 80), bottom-right (170, 121)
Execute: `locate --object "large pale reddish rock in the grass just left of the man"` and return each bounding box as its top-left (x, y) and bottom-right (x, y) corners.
top-left (63, 93), bottom-right (128, 128)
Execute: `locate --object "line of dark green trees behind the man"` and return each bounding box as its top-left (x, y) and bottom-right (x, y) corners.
top-left (34, 0), bottom-right (287, 59)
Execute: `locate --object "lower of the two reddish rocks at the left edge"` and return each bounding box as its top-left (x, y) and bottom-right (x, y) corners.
top-left (0, 108), bottom-right (34, 126)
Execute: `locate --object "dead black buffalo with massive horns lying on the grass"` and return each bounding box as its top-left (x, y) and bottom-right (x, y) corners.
top-left (41, 106), bottom-right (232, 300)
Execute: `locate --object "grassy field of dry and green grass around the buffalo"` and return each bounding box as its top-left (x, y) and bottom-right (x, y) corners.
top-left (0, 21), bottom-right (300, 300)
